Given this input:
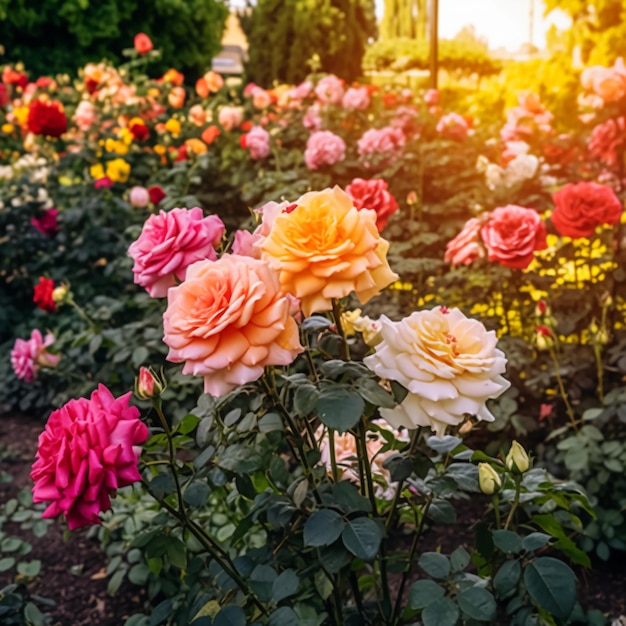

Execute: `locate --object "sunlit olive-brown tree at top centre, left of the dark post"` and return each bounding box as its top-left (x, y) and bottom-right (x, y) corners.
top-left (240, 0), bottom-right (376, 87)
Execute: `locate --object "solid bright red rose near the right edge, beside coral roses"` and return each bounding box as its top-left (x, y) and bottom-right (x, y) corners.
top-left (550, 182), bottom-right (623, 239)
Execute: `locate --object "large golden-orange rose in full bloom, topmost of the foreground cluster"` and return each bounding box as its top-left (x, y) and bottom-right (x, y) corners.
top-left (261, 187), bottom-right (398, 316)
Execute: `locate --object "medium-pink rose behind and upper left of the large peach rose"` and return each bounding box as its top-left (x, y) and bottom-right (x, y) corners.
top-left (128, 207), bottom-right (224, 298)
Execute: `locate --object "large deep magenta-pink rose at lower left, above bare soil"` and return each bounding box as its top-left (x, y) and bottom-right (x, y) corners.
top-left (30, 385), bottom-right (149, 530)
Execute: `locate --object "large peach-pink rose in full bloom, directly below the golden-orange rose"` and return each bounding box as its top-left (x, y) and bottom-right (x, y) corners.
top-left (163, 254), bottom-right (302, 396)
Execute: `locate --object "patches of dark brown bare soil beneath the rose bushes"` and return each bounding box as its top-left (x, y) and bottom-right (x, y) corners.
top-left (0, 415), bottom-right (626, 626)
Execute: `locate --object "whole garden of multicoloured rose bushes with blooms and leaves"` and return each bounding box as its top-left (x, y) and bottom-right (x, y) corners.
top-left (0, 2), bottom-right (626, 626)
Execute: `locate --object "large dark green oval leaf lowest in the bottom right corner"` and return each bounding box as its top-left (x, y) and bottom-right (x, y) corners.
top-left (524, 556), bottom-right (576, 619)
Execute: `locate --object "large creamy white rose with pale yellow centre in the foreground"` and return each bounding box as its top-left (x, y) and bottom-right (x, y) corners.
top-left (363, 307), bottom-right (510, 437)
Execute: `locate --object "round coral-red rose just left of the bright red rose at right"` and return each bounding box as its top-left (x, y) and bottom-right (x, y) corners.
top-left (480, 204), bottom-right (547, 270)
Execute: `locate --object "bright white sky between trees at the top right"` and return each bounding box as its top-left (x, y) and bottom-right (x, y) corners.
top-left (376, 0), bottom-right (567, 51)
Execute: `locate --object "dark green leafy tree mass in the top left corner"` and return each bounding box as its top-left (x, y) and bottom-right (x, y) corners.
top-left (0, 0), bottom-right (228, 76)
